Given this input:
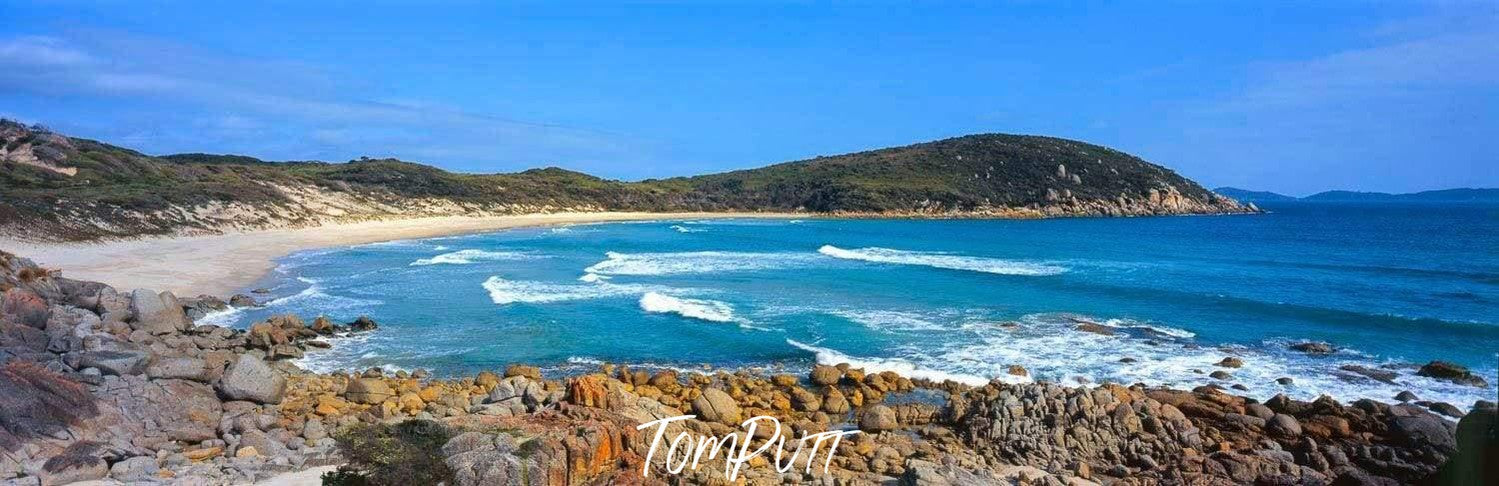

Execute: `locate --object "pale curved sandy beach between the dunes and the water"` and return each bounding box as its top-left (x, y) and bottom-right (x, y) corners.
top-left (0, 212), bottom-right (808, 297)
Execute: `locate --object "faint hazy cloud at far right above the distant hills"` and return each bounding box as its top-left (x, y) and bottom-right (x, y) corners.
top-left (1171, 14), bottom-right (1499, 192)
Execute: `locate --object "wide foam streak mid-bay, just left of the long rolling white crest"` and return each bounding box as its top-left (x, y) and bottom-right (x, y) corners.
top-left (583, 252), bottom-right (811, 276)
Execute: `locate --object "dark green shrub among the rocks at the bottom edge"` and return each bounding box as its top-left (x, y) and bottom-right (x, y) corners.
top-left (322, 420), bottom-right (453, 486)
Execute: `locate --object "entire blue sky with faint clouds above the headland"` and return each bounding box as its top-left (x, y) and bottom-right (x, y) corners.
top-left (0, 0), bottom-right (1499, 195)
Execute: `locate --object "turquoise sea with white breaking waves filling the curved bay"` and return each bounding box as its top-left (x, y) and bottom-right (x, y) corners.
top-left (213, 203), bottom-right (1499, 405)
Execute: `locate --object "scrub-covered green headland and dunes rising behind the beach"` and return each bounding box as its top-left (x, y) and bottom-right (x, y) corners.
top-left (0, 120), bottom-right (1255, 240)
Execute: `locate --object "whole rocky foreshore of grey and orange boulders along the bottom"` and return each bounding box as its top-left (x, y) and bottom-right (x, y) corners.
top-left (0, 252), bottom-right (1499, 485)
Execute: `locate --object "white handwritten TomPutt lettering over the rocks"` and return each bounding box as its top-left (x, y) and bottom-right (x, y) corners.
top-left (636, 416), bottom-right (859, 482)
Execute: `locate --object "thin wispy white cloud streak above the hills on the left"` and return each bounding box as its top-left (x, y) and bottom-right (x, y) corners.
top-left (0, 30), bottom-right (642, 173)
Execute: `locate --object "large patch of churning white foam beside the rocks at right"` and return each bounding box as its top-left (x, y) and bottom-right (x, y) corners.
top-left (799, 314), bottom-right (1493, 407)
